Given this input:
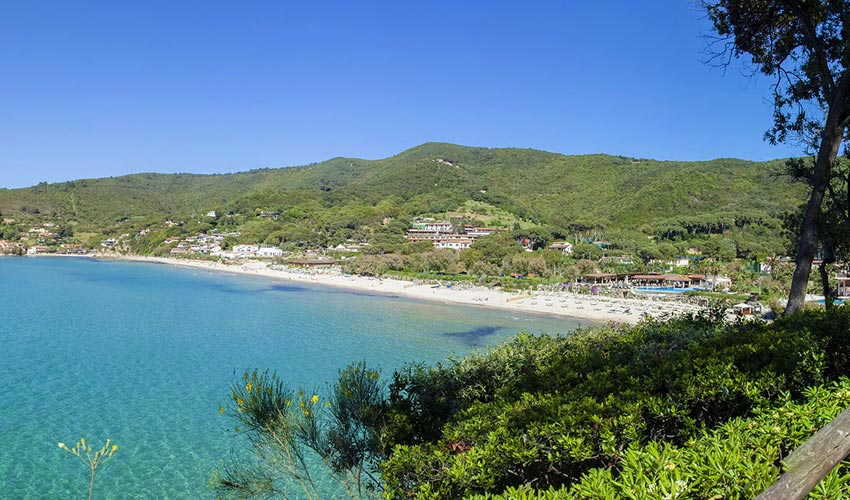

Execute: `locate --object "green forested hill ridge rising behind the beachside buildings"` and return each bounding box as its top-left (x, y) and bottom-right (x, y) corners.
top-left (0, 143), bottom-right (803, 247)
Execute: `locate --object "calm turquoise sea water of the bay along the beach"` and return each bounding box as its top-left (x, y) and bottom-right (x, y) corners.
top-left (0, 258), bottom-right (578, 499)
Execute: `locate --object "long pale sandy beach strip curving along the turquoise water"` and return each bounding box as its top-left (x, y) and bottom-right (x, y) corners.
top-left (91, 255), bottom-right (699, 324)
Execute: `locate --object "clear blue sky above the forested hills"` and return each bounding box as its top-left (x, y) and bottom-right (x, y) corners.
top-left (0, 0), bottom-right (799, 187)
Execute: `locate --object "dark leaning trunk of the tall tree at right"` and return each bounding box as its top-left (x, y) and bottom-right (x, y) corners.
top-left (785, 102), bottom-right (847, 316)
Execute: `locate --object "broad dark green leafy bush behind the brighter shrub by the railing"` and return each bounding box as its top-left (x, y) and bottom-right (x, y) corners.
top-left (383, 308), bottom-right (850, 499)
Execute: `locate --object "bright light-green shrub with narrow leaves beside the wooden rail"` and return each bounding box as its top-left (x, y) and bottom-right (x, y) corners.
top-left (474, 378), bottom-right (850, 500)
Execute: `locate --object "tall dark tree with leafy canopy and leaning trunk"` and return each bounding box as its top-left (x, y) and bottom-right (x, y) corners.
top-left (704, 0), bottom-right (850, 313)
